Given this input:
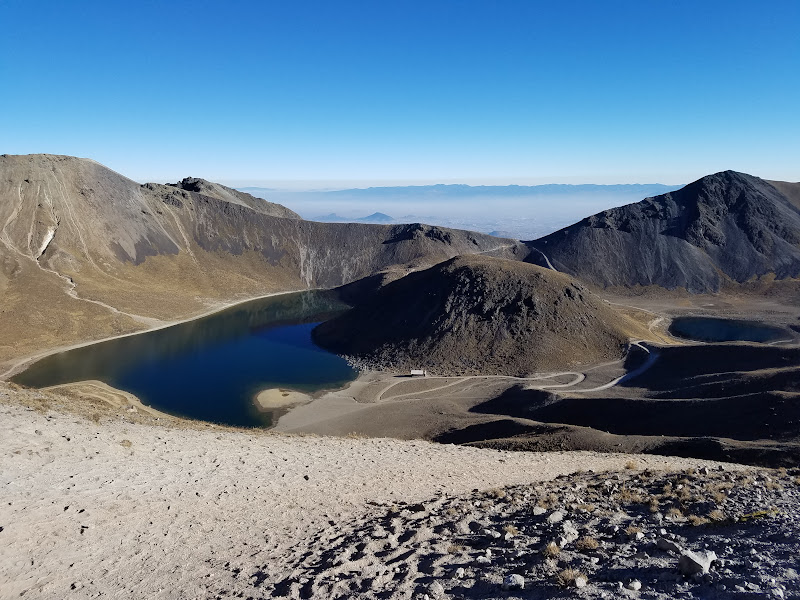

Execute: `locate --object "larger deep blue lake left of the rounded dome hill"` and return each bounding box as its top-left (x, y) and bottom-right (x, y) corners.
top-left (12, 291), bottom-right (357, 427)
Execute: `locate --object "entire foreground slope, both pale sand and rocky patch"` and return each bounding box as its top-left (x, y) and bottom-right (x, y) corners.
top-left (0, 383), bottom-right (800, 600)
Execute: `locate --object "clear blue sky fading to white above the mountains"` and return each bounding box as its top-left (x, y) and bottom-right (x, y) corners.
top-left (0, 0), bottom-right (800, 185)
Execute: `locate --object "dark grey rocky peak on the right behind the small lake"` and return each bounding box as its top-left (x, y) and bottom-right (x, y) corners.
top-left (528, 171), bottom-right (800, 293)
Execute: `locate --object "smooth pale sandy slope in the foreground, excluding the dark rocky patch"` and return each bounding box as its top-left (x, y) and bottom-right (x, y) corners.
top-left (0, 404), bottom-right (744, 599)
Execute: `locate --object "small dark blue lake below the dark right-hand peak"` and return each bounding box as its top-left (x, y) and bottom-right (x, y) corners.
top-left (669, 317), bottom-right (793, 343)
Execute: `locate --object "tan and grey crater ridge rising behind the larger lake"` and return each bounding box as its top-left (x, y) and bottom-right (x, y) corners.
top-left (0, 155), bottom-right (527, 373)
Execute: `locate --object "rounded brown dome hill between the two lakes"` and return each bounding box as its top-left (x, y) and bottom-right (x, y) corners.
top-left (313, 256), bottom-right (642, 375)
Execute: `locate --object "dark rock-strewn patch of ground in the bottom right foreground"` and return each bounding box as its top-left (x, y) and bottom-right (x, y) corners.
top-left (290, 462), bottom-right (800, 599)
